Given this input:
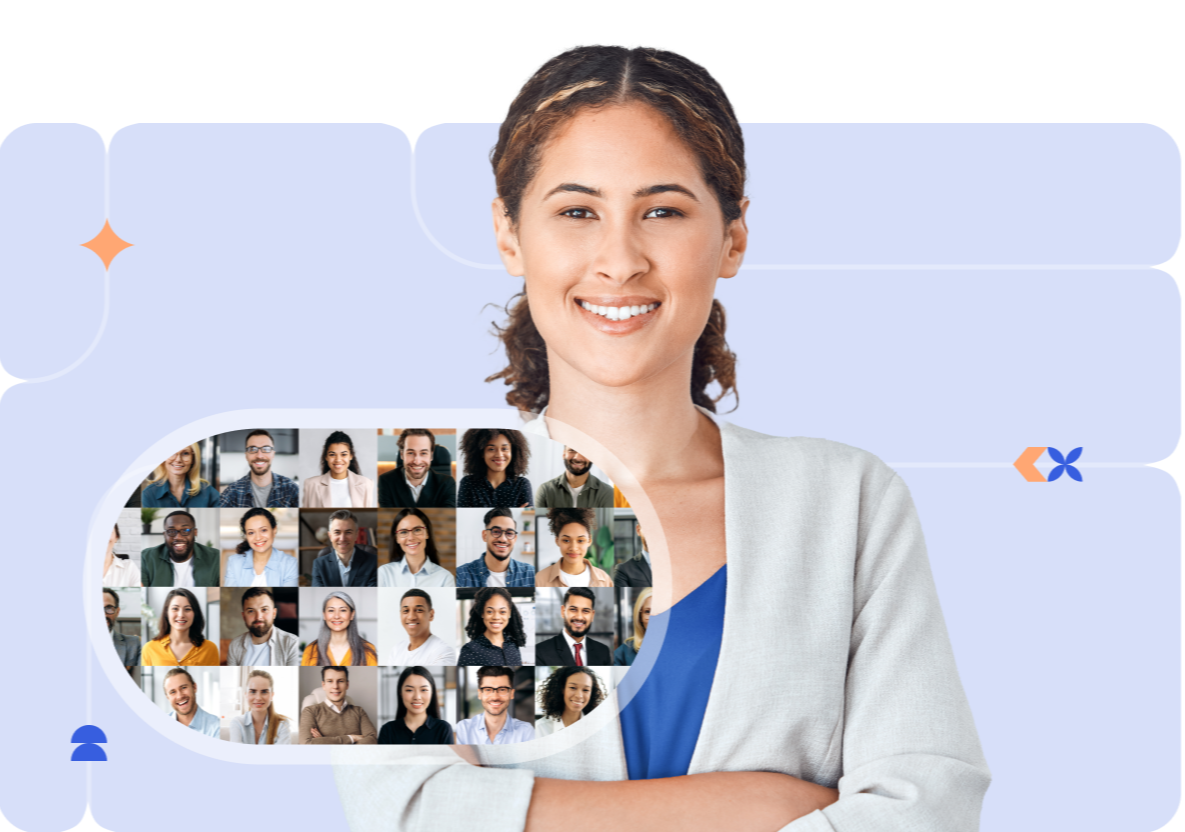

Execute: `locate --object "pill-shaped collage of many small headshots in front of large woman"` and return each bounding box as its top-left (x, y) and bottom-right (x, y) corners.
top-left (102, 425), bottom-right (652, 744)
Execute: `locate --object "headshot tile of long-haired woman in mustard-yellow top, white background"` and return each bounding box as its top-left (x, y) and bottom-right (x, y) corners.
top-left (140, 587), bottom-right (220, 667)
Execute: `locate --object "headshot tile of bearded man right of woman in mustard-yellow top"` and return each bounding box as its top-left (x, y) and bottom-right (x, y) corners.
top-left (220, 587), bottom-right (302, 673)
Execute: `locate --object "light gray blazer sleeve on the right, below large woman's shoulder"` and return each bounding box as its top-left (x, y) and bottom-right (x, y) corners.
top-left (784, 474), bottom-right (991, 832)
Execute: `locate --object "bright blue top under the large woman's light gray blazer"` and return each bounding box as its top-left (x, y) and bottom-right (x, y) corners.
top-left (621, 564), bottom-right (728, 780)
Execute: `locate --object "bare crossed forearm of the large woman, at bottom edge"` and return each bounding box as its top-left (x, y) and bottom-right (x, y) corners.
top-left (525, 772), bottom-right (839, 832)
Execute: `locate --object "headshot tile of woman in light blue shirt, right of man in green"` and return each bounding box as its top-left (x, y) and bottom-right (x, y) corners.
top-left (219, 507), bottom-right (300, 587)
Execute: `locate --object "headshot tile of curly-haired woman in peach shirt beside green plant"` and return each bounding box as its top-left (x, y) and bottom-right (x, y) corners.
top-left (534, 508), bottom-right (614, 587)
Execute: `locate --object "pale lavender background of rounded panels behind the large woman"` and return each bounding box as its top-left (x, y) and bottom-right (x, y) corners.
top-left (0, 124), bottom-right (1185, 832)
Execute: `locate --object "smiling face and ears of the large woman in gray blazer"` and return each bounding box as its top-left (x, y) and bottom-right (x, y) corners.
top-left (494, 103), bottom-right (747, 388)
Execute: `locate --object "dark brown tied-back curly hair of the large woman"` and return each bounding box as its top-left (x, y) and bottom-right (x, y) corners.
top-left (486, 44), bottom-right (745, 412)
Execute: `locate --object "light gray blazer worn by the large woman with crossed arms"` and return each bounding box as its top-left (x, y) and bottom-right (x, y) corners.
top-left (334, 420), bottom-right (991, 832)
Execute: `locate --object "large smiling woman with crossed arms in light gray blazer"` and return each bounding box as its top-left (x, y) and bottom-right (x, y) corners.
top-left (338, 44), bottom-right (991, 832)
